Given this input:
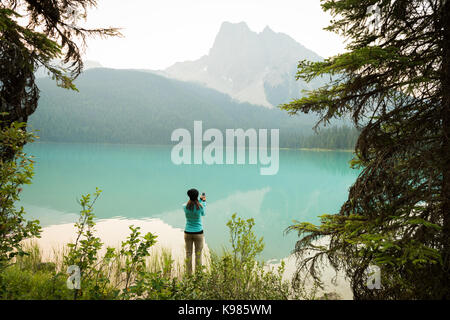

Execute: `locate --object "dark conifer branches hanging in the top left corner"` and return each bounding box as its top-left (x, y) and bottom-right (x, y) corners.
top-left (0, 0), bottom-right (119, 150)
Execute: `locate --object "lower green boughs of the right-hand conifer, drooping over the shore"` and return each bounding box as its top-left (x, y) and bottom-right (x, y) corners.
top-left (288, 215), bottom-right (442, 292)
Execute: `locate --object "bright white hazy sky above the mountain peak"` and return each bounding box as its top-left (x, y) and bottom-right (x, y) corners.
top-left (82, 0), bottom-right (345, 69)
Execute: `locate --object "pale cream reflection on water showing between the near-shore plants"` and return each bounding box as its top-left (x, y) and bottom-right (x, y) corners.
top-left (27, 218), bottom-right (353, 300)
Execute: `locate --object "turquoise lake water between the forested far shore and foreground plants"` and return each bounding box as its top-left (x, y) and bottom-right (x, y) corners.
top-left (20, 143), bottom-right (359, 259)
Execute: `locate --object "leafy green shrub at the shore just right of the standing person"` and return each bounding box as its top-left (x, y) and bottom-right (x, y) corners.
top-left (175, 214), bottom-right (298, 300)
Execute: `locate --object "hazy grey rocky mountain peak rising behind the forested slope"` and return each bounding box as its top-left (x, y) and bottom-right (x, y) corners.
top-left (166, 22), bottom-right (320, 107)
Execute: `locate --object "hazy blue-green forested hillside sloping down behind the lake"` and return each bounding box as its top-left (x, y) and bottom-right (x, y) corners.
top-left (30, 68), bottom-right (354, 148)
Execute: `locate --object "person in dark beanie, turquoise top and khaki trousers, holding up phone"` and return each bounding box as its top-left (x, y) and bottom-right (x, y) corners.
top-left (183, 189), bottom-right (206, 274)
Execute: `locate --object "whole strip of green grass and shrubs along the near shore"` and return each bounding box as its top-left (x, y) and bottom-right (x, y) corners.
top-left (0, 211), bottom-right (340, 300)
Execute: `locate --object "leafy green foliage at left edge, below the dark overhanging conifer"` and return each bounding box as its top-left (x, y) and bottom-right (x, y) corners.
top-left (0, 122), bottom-right (40, 270)
